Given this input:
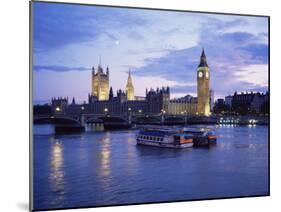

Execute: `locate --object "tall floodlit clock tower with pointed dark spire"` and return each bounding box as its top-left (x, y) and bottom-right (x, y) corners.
top-left (197, 49), bottom-right (211, 116)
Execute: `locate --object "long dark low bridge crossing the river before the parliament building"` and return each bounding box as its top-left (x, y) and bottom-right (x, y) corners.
top-left (33, 113), bottom-right (269, 126)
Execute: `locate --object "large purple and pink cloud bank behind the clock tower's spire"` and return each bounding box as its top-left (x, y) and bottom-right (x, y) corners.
top-left (134, 21), bottom-right (268, 96)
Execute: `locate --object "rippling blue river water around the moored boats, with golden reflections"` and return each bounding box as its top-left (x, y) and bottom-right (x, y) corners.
top-left (33, 125), bottom-right (269, 210)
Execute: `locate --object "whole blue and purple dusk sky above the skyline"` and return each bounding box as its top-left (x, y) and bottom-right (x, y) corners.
top-left (33, 2), bottom-right (268, 103)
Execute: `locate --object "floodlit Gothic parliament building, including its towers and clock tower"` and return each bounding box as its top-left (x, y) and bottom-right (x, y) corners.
top-left (52, 50), bottom-right (213, 116)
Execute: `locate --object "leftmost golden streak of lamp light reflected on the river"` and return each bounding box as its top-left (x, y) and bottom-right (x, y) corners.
top-left (49, 137), bottom-right (65, 205)
